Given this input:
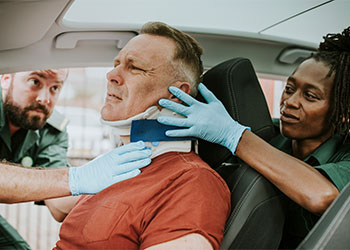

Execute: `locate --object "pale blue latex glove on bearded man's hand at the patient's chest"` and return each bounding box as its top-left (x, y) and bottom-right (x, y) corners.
top-left (69, 141), bottom-right (152, 195)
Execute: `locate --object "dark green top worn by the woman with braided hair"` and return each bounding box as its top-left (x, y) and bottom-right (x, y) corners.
top-left (270, 119), bottom-right (350, 248)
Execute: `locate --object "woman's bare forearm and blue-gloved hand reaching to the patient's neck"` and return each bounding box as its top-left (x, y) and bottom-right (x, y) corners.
top-left (158, 84), bottom-right (338, 214)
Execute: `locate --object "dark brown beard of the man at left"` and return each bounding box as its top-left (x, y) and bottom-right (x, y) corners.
top-left (3, 98), bottom-right (50, 130)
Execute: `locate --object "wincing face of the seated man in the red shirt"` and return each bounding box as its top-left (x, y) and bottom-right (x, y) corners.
top-left (101, 34), bottom-right (175, 121)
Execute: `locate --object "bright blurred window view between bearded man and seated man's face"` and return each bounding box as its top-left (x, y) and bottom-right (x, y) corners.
top-left (56, 67), bottom-right (112, 165)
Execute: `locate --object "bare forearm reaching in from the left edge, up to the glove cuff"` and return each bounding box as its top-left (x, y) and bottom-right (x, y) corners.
top-left (0, 163), bottom-right (71, 203)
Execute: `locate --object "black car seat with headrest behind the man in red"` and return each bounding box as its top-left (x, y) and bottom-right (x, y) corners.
top-left (197, 58), bottom-right (285, 249)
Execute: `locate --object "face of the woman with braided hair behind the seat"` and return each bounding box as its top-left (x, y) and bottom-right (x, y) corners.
top-left (280, 59), bottom-right (334, 142)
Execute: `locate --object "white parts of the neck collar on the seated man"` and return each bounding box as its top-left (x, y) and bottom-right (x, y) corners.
top-left (101, 106), bottom-right (191, 159)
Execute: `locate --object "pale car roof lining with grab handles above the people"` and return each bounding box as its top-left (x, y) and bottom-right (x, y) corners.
top-left (0, 0), bottom-right (350, 76)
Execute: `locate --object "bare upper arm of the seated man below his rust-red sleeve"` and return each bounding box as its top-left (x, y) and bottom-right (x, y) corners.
top-left (146, 234), bottom-right (213, 250)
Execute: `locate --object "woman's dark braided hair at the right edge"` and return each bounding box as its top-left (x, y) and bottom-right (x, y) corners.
top-left (312, 27), bottom-right (350, 137)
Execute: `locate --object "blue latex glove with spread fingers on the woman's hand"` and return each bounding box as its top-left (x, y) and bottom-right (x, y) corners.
top-left (157, 83), bottom-right (250, 154)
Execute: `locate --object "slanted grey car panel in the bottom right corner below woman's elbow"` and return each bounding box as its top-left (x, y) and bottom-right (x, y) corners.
top-left (297, 183), bottom-right (350, 249)
